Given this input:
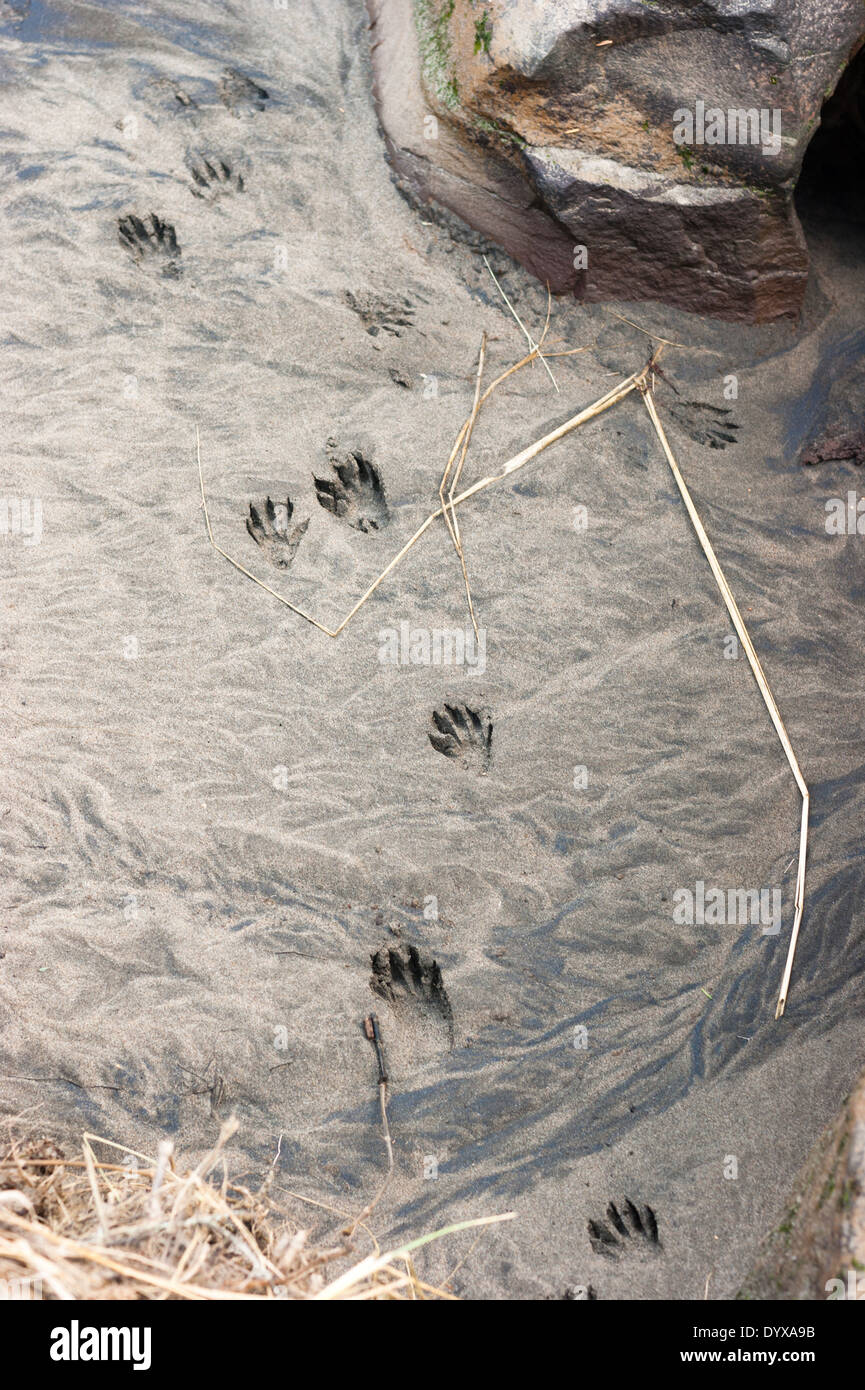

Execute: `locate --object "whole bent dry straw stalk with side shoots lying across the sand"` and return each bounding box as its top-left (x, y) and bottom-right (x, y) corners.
top-left (195, 353), bottom-right (809, 1019)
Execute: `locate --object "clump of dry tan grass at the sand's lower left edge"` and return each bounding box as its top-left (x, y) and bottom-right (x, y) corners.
top-left (0, 1120), bottom-right (514, 1301)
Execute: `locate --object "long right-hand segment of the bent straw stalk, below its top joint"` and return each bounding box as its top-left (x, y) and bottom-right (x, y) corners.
top-left (640, 381), bottom-right (809, 1019)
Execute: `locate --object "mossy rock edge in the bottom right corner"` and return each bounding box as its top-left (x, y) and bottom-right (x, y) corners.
top-left (738, 1076), bottom-right (865, 1300)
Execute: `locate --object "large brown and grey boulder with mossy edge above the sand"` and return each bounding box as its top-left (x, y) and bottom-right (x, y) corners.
top-left (367, 0), bottom-right (865, 322)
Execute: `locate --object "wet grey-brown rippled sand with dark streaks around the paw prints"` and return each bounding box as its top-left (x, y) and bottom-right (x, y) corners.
top-left (0, 0), bottom-right (865, 1298)
